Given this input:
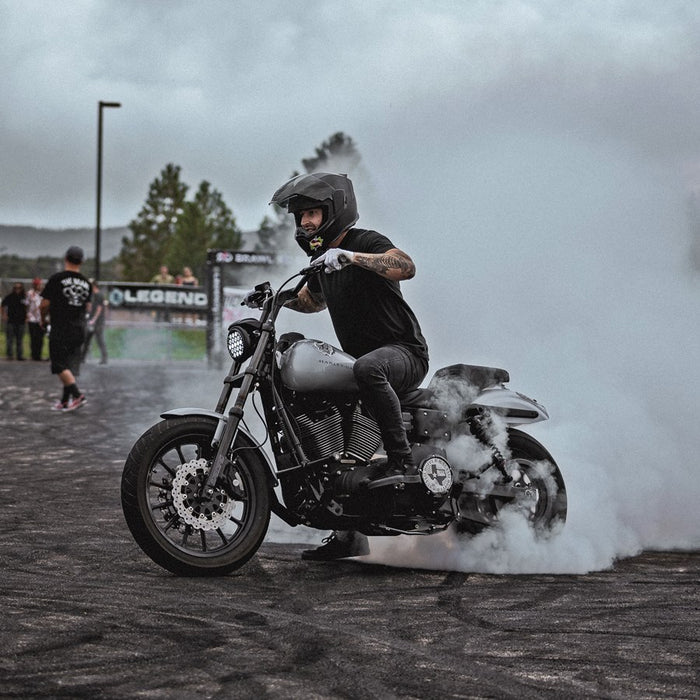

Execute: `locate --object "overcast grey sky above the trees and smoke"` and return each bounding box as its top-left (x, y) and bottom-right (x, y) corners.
top-left (0, 0), bottom-right (700, 228)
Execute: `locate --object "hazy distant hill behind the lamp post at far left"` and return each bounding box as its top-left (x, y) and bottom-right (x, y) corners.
top-left (0, 224), bottom-right (131, 261)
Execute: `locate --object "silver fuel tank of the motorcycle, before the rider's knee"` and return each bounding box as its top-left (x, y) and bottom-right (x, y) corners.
top-left (279, 338), bottom-right (358, 392)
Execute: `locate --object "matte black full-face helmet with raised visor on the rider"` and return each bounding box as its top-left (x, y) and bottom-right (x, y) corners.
top-left (270, 173), bottom-right (359, 257)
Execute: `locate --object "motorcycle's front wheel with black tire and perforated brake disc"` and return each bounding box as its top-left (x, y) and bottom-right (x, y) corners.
top-left (122, 416), bottom-right (270, 576)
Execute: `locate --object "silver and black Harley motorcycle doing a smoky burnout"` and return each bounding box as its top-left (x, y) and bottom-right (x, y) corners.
top-left (121, 266), bottom-right (567, 576)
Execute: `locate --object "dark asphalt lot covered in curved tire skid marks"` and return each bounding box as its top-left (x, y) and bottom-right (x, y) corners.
top-left (0, 361), bottom-right (700, 698)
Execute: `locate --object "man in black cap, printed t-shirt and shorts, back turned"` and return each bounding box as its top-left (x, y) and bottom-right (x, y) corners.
top-left (41, 246), bottom-right (91, 411)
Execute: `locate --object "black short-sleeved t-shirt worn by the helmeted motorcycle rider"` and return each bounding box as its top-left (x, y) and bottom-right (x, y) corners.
top-left (309, 228), bottom-right (428, 361)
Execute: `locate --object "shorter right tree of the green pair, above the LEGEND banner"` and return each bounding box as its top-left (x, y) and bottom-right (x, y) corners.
top-left (165, 180), bottom-right (241, 281)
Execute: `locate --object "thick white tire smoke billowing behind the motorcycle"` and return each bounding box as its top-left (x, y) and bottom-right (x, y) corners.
top-left (352, 134), bottom-right (700, 573)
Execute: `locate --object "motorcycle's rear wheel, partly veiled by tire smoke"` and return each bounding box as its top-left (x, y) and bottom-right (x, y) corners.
top-left (458, 428), bottom-right (567, 534)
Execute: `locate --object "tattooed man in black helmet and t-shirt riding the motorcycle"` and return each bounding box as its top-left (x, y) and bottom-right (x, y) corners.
top-left (271, 173), bottom-right (428, 560)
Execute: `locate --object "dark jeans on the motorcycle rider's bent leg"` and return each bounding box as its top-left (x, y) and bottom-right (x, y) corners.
top-left (354, 345), bottom-right (428, 455)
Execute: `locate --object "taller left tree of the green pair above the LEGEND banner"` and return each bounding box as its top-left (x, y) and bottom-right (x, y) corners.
top-left (119, 163), bottom-right (188, 281)
